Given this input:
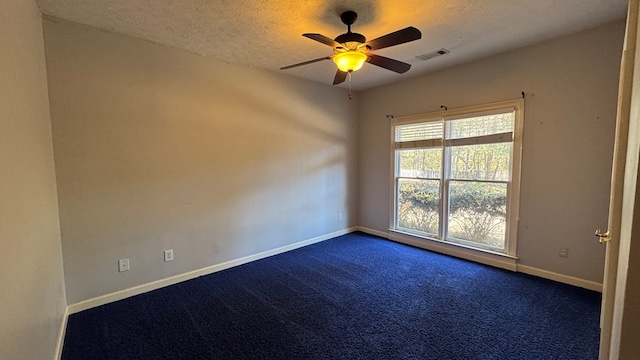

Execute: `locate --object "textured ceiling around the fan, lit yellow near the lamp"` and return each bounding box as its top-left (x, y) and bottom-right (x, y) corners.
top-left (37, 0), bottom-right (627, 90)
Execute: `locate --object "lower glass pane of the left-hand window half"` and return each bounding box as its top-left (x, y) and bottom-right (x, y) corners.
top-left (397, 179), bottom-right (440, 235)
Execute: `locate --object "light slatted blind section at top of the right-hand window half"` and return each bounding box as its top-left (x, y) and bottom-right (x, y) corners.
top-left (447, 112), bottom-right (514, 139)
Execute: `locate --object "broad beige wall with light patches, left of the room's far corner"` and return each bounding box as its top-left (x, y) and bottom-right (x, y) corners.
top-left (44, 18), bottom-right (357, 304)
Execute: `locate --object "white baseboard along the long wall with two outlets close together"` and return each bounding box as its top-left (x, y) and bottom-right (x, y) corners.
top-left (67, 227), bottom-right (357, 314)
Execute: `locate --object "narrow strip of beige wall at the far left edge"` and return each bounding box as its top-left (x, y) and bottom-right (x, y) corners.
top-left (0, 0), bottom-right (66, 359)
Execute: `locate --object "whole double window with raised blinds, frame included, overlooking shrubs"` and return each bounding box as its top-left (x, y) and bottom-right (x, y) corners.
top-left (391, 100), bottom-right (523, 256)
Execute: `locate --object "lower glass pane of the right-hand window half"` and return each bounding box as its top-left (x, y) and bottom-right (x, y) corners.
top-left (448, 181), bottom-right (507, 249)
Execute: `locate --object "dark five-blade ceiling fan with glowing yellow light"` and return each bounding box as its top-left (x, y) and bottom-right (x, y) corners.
top-left (280, 11), bottom-right (422, 85)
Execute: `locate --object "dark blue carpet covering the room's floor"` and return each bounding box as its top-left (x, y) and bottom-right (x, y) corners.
top-left (62, 233), bottom-right (600, 360)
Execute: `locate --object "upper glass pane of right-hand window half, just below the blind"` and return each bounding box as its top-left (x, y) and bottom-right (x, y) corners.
top-left (451, 143), bottom-right (512, 181)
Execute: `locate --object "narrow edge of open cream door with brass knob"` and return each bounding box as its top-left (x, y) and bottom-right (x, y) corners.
top-left (596, 0), bottom-right (640, 360)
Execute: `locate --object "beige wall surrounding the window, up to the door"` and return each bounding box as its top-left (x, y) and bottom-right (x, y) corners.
top-left (358, 22), bottom-right (624, 282)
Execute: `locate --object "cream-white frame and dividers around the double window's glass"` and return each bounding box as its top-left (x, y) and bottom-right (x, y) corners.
top-left (389, 99), bottom-right (524, 258)
